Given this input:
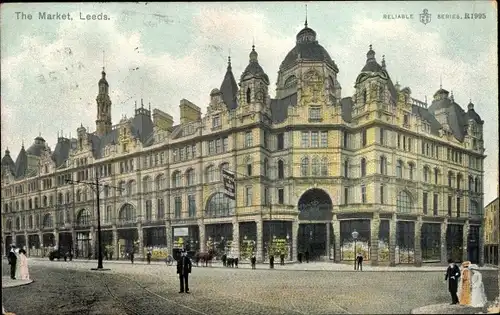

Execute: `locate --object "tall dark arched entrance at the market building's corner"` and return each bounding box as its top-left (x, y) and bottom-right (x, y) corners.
top-left (297, 188), bottom-right (334, 260)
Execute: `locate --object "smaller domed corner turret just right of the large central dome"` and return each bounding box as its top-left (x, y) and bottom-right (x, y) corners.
top-left (354, 45), bottom-right (397, 110)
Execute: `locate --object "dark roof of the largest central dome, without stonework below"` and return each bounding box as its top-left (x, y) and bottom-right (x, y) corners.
top-left (280, 23), bottom-right (338, 71)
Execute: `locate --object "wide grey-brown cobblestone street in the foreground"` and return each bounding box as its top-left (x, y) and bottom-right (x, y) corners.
top-left (3, 260), bottom-right (498, 315)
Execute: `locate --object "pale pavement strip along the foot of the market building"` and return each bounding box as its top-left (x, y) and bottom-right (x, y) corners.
top-left (24, 257), bottom-right (499, 272)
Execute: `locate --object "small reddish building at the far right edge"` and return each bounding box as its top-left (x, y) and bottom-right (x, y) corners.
top-left (484, 197), bottom-right (500, 265)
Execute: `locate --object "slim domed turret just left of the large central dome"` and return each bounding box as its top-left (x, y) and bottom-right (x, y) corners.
top-left (239, 45), bottom-right (269, 106)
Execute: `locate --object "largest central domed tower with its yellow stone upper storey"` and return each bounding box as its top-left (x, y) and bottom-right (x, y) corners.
top-left (276, 19), bottom-right (341, 105)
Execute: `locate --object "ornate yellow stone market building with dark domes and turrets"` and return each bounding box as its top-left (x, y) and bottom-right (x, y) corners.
top-left (1, 24), bottom-right (485, 265)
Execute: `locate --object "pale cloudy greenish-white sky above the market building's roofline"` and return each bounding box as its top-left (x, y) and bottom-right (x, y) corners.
top-left (0, 1), bottom-right (499, 205)
